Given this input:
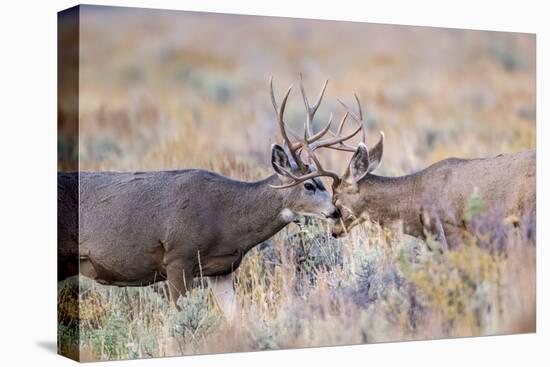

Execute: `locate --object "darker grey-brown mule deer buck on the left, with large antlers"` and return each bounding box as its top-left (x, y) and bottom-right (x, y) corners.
top-left (58, 80), bottom-right (361, 314)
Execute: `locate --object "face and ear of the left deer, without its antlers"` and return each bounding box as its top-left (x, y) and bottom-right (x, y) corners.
top-left (271, 145), bottom-right (340, 223)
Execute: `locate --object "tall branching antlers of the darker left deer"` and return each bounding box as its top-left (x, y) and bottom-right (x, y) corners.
top-left (269, 74), bottom-right (340, 189)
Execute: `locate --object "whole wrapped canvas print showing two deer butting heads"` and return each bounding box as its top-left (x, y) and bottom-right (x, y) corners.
top-left (57, 6), bottom-right (536, 361)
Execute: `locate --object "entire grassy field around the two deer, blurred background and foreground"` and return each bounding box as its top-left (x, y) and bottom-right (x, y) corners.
top-left (59, 8), bottom-right (536, 360)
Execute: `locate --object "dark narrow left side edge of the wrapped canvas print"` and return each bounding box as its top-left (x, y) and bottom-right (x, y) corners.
top-left (57, 7), bottom-right (80, 361)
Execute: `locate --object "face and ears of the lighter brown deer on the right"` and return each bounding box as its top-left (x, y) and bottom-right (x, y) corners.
top-left (332, 133), bottom-right (384, 237)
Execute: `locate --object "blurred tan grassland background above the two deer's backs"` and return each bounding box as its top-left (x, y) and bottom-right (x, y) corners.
top-left (73, 6), bottom-right (536, 179)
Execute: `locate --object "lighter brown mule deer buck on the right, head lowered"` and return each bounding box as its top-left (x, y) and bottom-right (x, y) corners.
top-left (329, 96), bottom-right (536, 248)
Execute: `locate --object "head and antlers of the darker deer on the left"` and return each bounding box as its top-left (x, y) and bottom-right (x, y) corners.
top-left (269, 75), bottom-right (362, 222)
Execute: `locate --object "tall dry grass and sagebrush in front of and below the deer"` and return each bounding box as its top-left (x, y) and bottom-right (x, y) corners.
top-left (60, 208), bottom-right (536, 360)
